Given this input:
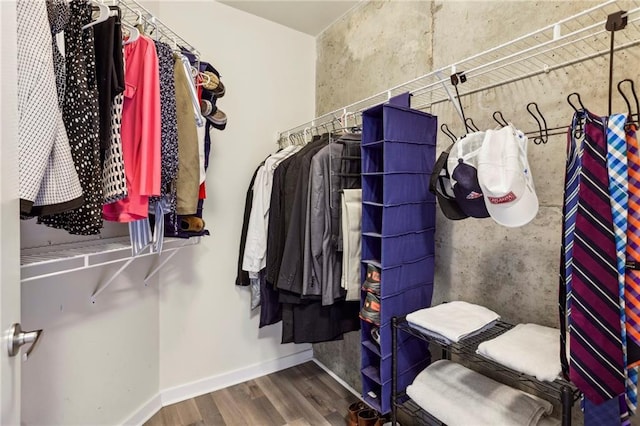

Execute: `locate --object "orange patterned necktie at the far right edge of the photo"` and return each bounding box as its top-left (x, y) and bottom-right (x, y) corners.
top-left (625, 124), bottom-right (640, 367)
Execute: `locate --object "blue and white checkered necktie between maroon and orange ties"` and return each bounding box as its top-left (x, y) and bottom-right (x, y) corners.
top-left (607, 114), bottom-right (638, 412)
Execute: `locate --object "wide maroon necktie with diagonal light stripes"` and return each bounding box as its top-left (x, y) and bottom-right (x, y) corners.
top-left (569, 115), bottom-right (625, 404)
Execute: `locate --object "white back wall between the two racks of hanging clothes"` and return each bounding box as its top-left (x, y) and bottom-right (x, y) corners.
top-left (155, 1), bottom-right (316, 389)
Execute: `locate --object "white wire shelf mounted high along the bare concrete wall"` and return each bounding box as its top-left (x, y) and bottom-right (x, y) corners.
top-left (278, 0), bottom-right (640, 143)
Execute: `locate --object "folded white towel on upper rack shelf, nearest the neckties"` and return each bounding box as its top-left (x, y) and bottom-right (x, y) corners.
top-left (476, 324), bottom-right (562, 382)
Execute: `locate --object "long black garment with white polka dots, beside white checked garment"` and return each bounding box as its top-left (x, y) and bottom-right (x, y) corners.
top-left (39, 0), bottom-right (103, 235)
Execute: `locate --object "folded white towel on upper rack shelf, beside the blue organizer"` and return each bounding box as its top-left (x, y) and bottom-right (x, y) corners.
top-left (407, 301), bottom-right (500, 342)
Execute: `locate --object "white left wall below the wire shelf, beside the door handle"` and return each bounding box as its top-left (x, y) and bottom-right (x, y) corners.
top-left (22, 262), bottom-right (162, 425)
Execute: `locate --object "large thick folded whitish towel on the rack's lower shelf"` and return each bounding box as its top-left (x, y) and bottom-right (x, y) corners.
top-left (407, 360), bottom-right (553, 426)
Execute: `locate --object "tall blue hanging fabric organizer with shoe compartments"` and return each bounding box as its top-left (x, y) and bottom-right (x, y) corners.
top-left (361, 93), bottom-right (438, 413)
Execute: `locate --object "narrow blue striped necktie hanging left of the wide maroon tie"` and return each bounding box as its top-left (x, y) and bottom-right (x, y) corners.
top-left (558, 111), bottom-right (585, 378)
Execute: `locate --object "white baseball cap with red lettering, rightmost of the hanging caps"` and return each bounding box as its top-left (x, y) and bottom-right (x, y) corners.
top-left (478, 124), bottom-right (538, 228)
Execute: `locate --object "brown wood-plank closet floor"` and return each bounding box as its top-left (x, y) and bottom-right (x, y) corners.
top-left (145, 361), bottom-right (358, 426)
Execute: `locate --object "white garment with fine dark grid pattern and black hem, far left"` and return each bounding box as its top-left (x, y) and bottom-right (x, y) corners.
top-left (16, 0), bottom-right (84, 216)
